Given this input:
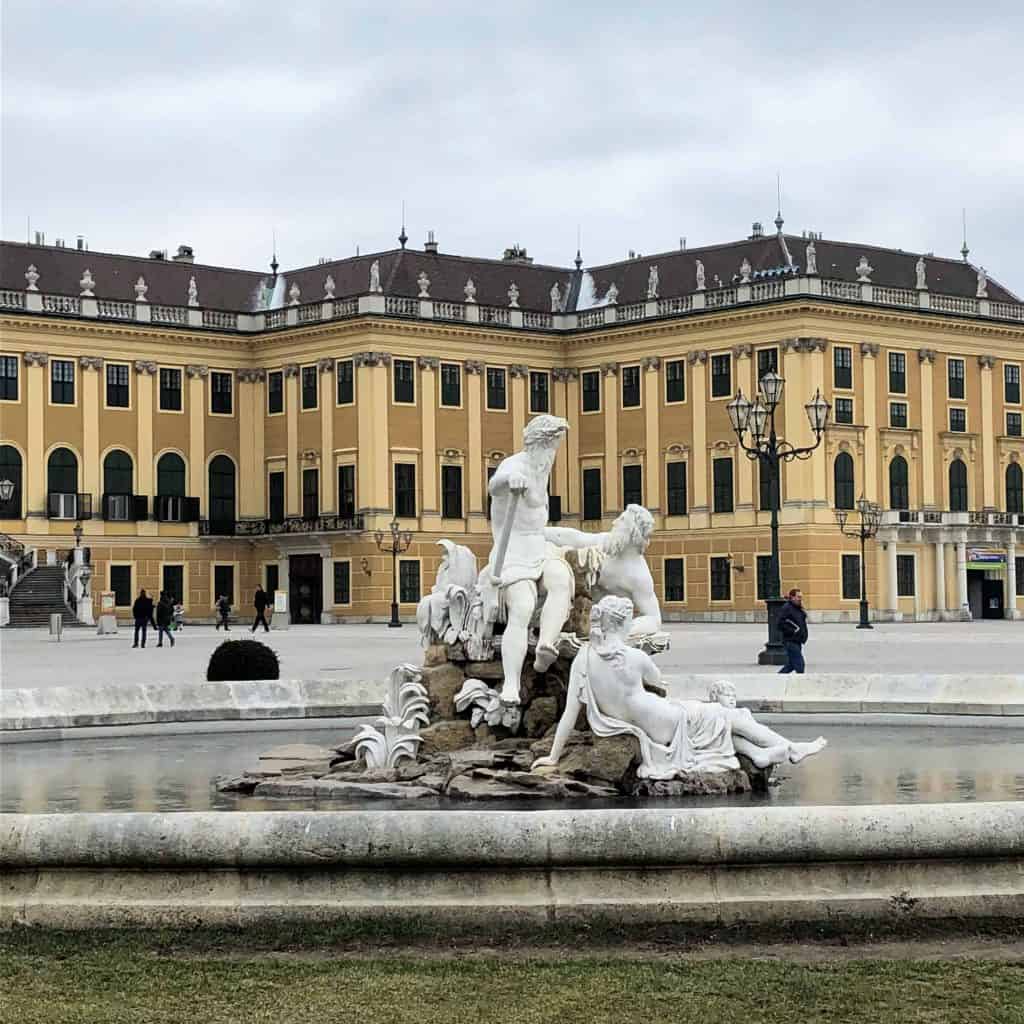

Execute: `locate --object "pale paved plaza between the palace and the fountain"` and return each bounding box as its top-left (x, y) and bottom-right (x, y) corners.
top-left (0, 621), bottom-right (1024, 688)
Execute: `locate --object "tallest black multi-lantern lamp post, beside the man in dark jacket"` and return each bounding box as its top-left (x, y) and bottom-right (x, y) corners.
top-left (727, 370), bottom-right (831, 665)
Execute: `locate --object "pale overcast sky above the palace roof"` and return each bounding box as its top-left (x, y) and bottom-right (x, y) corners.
top-left (2, 0), bottom-right (1024, 295)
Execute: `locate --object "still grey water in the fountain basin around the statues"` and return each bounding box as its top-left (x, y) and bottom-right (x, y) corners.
top-left (0, 716), bottom-right (1024, 813)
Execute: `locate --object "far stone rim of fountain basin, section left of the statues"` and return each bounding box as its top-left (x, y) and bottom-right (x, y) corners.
top-left (0, 680), bottom-right (386, 738)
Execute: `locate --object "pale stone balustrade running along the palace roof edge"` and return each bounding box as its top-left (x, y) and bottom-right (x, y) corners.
top-left (8, 275), bottom-right (1024, 334)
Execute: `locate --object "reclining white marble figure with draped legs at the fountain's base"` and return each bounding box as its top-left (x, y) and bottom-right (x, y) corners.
top-left (532, 595), bottom-right (825, 779)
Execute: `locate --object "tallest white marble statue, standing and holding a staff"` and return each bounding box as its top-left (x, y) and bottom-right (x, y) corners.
top-left (479, 415), bottom-right (574, 705)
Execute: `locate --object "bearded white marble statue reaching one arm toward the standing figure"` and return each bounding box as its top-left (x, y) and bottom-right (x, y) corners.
top-left (544, 505), bottom-right (662, 641)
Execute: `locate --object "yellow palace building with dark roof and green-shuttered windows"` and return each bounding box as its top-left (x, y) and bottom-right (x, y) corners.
top-left (0, 221), bottom-right (1024, 623)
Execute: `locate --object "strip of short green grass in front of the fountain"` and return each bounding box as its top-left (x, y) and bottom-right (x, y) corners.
top-left (6, 932), bottom-right (1024, 1024)
